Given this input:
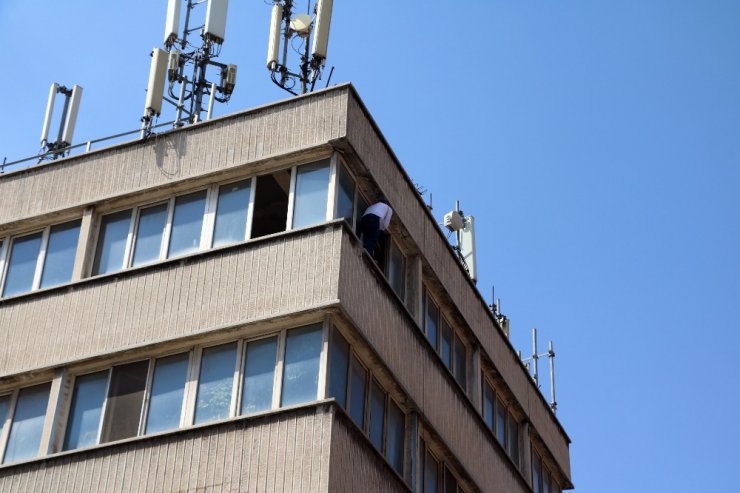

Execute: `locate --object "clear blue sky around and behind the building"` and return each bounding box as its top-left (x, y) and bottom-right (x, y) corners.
top-left (0, 0), bottom-right (740, 493)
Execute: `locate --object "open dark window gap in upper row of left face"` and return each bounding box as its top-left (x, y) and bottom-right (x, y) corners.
top-left (252, 169), bottom-right (290, 238)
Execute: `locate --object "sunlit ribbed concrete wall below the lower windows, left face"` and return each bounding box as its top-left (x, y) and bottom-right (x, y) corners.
top-left (0, 405), bottom-right (332, 493)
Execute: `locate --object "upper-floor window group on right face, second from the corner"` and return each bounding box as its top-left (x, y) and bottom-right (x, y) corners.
top-left (423, 289), bottom-right (468, 390)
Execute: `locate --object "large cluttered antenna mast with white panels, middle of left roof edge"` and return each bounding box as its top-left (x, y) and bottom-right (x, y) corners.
top-left (141, 0), bottom-right (236, 138)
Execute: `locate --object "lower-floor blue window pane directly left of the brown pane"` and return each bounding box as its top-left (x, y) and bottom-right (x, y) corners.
top-left (63, 371), bottom-right (108, 450)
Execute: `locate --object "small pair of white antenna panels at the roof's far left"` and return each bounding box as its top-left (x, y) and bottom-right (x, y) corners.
top-left (39, 82), bottom-right (82, 162)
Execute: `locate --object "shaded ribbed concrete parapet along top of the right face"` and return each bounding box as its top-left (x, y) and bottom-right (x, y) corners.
top-left (347, 93), bottom-right (570, 476)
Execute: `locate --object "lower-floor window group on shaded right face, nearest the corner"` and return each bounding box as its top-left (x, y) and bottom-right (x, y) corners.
top-left (329, 329), bottom-right (406, 476)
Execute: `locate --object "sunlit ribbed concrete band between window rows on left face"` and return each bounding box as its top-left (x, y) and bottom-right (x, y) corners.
top-left (0, 224), bottom-right (341, 376)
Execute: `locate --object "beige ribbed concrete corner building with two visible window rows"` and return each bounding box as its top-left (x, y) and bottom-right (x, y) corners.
top-left (0, 85), bottom-right (572, 493)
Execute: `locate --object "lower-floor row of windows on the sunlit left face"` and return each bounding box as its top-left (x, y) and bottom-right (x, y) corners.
top-left (0, 324), bottom-right (323, 464)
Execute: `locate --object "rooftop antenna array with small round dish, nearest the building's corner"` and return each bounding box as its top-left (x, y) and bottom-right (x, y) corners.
top-left (267, 0), bottom-right (334, 95)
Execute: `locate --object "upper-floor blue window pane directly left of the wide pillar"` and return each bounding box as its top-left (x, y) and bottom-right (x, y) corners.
top-left (41, 221), bottom-right (80, 288)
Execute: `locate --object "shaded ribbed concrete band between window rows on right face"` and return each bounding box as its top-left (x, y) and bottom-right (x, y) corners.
top-left (339, 235), bottom-right (528, 492)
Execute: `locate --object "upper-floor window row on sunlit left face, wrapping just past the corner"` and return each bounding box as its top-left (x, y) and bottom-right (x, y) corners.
top-left (0, 159), bottom-right (370, 297)
